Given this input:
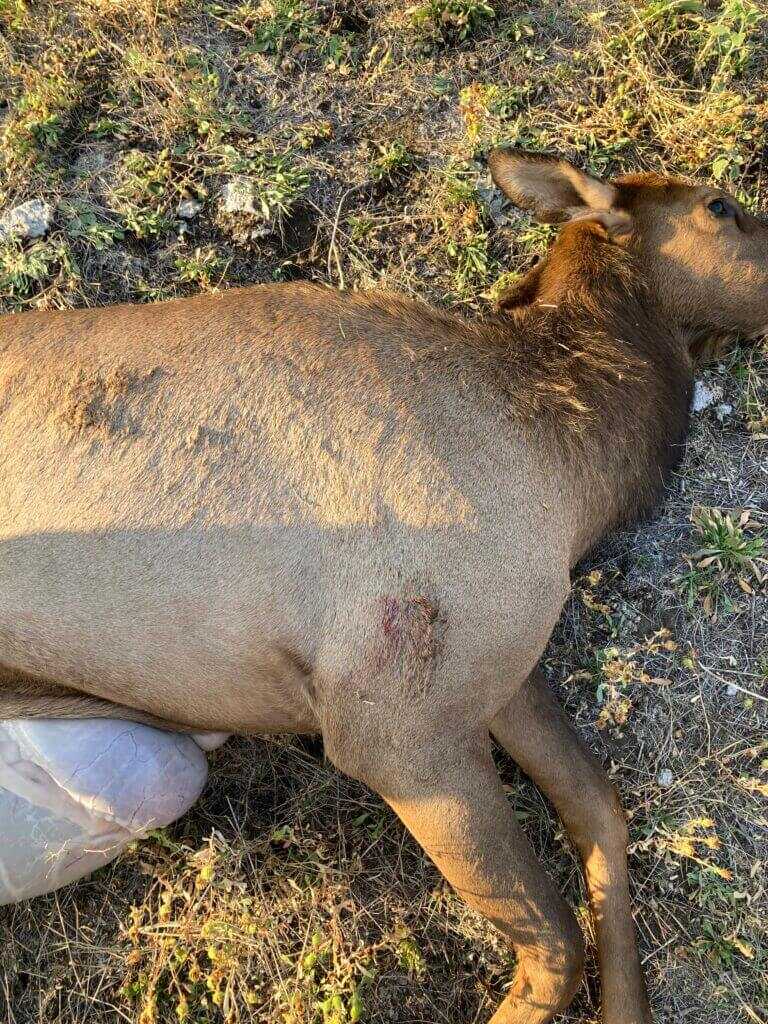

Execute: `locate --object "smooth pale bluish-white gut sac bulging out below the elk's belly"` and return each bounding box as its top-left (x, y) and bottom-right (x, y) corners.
top-left (0, 719), bottom-right (220, 905)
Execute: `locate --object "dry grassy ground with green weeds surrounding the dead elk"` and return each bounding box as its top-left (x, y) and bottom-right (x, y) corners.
top-left (0, 0), bottom-right (768, 1024)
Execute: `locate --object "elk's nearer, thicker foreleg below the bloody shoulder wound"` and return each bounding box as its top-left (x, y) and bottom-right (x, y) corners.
top-left (326, 733), bottom-right (584, 1024)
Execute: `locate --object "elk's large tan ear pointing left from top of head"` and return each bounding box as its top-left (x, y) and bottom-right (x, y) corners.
top-left (488, 148), bottom-right (616, 224)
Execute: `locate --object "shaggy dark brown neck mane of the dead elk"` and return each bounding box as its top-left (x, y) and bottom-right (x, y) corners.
top-left (479, 222), bottom-right (692, 550)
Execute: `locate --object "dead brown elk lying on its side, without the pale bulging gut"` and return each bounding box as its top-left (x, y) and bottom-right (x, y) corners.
top-left (0, 151), bottom-right (768, 1024)
